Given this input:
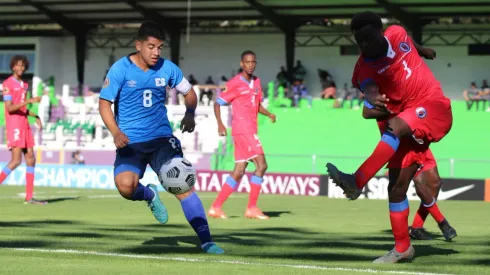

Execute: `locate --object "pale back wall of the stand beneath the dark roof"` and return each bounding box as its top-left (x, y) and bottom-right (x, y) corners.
top-left (0, 34), bottom-right (490, 98)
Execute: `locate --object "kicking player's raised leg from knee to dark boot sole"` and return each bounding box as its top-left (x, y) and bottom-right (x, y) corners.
top-left (327, 117), bottom-right (412, 200)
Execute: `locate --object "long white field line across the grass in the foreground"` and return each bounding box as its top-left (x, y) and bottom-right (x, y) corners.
top-left (3, 247), bottom-right (456, 275)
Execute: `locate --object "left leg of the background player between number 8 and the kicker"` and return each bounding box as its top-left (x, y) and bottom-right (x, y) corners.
top-left (208, 161), bottom-right (248, 219)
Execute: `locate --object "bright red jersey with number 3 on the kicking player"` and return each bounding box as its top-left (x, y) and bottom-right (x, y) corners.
top-left (352, 25), bottom-right (445, 113)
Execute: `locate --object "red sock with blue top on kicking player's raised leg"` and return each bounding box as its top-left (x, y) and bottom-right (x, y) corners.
top-left (354, 133), bottom-right (400, 189)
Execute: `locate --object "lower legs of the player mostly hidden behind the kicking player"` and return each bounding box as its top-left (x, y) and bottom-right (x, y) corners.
top-left (410, 166), bottom-right (457, 241)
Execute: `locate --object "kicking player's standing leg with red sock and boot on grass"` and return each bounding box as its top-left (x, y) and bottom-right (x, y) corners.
top-left (374, 163), bottom-right (419, 263)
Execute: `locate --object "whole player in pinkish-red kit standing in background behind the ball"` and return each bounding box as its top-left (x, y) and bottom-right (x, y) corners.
top-left (208, 51), bottom-right (276, 220)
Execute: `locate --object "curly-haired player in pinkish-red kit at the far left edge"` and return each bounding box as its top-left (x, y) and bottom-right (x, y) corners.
top-left (0, 55), bottom-right (46, 204)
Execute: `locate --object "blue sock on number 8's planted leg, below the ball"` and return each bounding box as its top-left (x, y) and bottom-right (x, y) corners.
top-left (180, 193), bottom-right (212, 245)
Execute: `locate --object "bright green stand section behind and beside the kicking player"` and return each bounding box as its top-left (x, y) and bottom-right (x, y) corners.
top-left (213, 96), bottom-right (490, 178)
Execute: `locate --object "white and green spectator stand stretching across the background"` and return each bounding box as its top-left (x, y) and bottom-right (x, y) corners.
top-left (0, 82), bottom-right (490, 181)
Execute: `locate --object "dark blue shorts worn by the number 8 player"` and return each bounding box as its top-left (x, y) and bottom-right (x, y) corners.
top-left (114, 136), bottom-right (184, 179)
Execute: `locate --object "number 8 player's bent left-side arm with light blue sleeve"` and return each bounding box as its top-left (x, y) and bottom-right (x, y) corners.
top-left (99, 63), bottom-right (129, 148)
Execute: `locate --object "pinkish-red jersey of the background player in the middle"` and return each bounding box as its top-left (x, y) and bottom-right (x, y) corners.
top-left (218, 74), bottom-right (263, 136)
